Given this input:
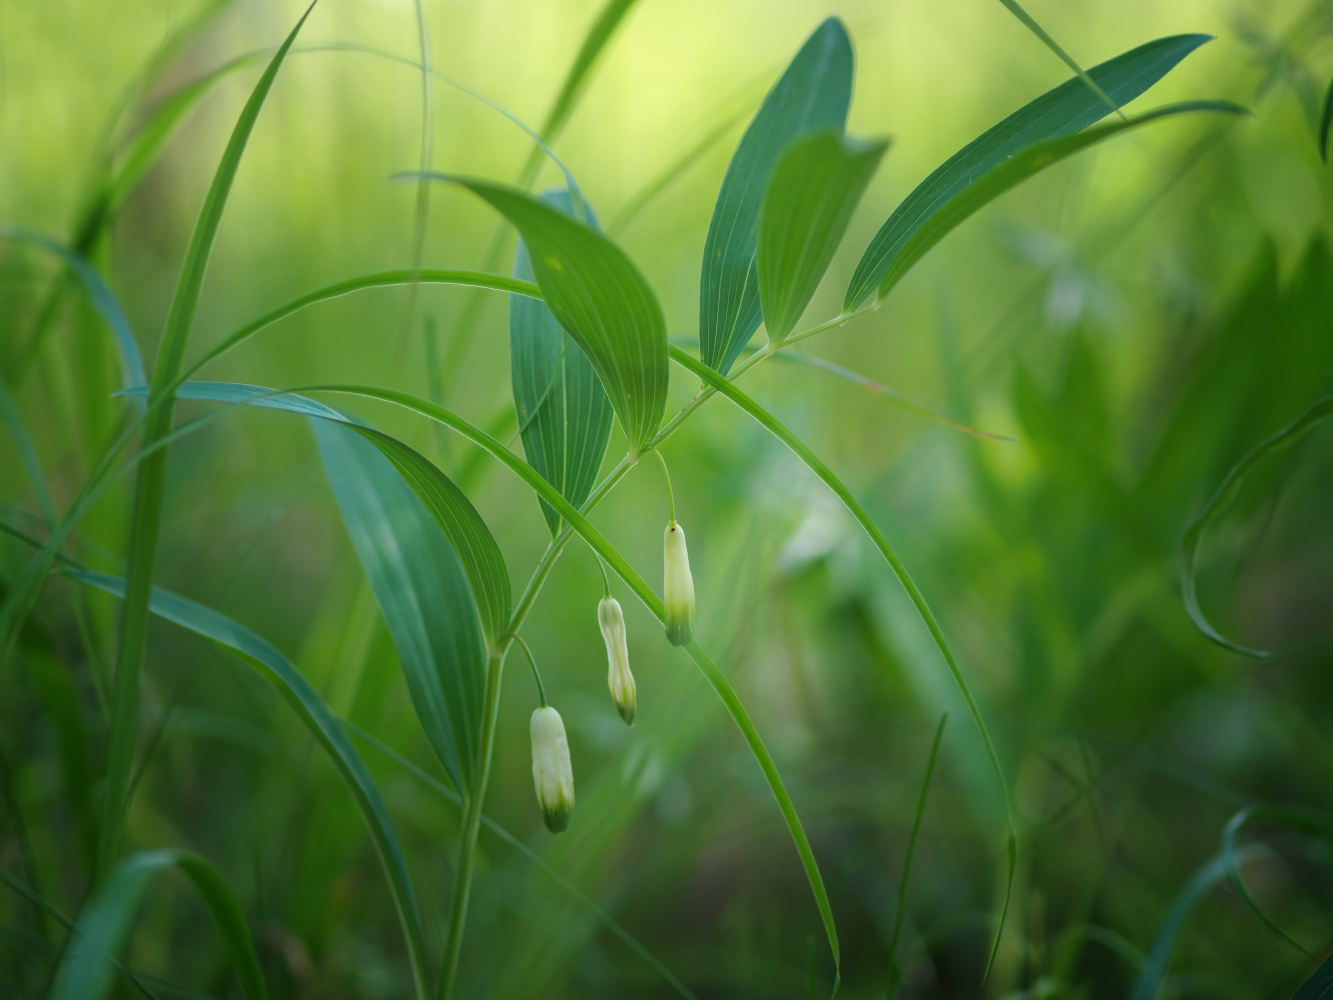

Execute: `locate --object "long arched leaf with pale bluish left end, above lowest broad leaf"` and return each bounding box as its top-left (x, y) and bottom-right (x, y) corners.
top-left (125, 381), bottom-right (513, 645)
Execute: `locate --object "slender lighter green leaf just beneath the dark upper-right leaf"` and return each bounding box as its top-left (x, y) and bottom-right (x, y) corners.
top-left (842, 101), bottom-right (1249, 311)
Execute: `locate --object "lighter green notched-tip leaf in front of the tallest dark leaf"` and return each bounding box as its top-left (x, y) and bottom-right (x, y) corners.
top-left (754, 128), bottom-right (889, 344)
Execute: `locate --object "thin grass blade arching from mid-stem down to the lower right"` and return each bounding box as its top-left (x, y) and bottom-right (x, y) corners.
top-left (661, 347), bottom-right (1018, 977)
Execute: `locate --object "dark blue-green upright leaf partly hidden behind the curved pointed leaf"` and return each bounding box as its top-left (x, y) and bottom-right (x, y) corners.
top-left (509, 188), bottom-right (612, 535)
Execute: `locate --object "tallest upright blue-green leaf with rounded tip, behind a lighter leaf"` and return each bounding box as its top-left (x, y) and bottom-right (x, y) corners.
top-left (698, 17), bottom-right (852, 375)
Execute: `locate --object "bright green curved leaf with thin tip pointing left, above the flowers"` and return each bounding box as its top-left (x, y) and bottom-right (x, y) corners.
top-left (452, 177), bottom-right (670, 452)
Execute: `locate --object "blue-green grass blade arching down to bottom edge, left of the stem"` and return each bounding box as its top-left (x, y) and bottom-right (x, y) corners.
top-left (65, 569), bottom-right (431, 1000)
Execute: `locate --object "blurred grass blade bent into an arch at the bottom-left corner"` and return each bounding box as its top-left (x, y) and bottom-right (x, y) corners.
top-left (51, 851), bottom-right (268, 1000)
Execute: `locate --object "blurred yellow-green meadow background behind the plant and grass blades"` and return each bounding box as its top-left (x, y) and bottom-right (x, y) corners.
top-left (0, 0), bottom-right (1333, 997)
